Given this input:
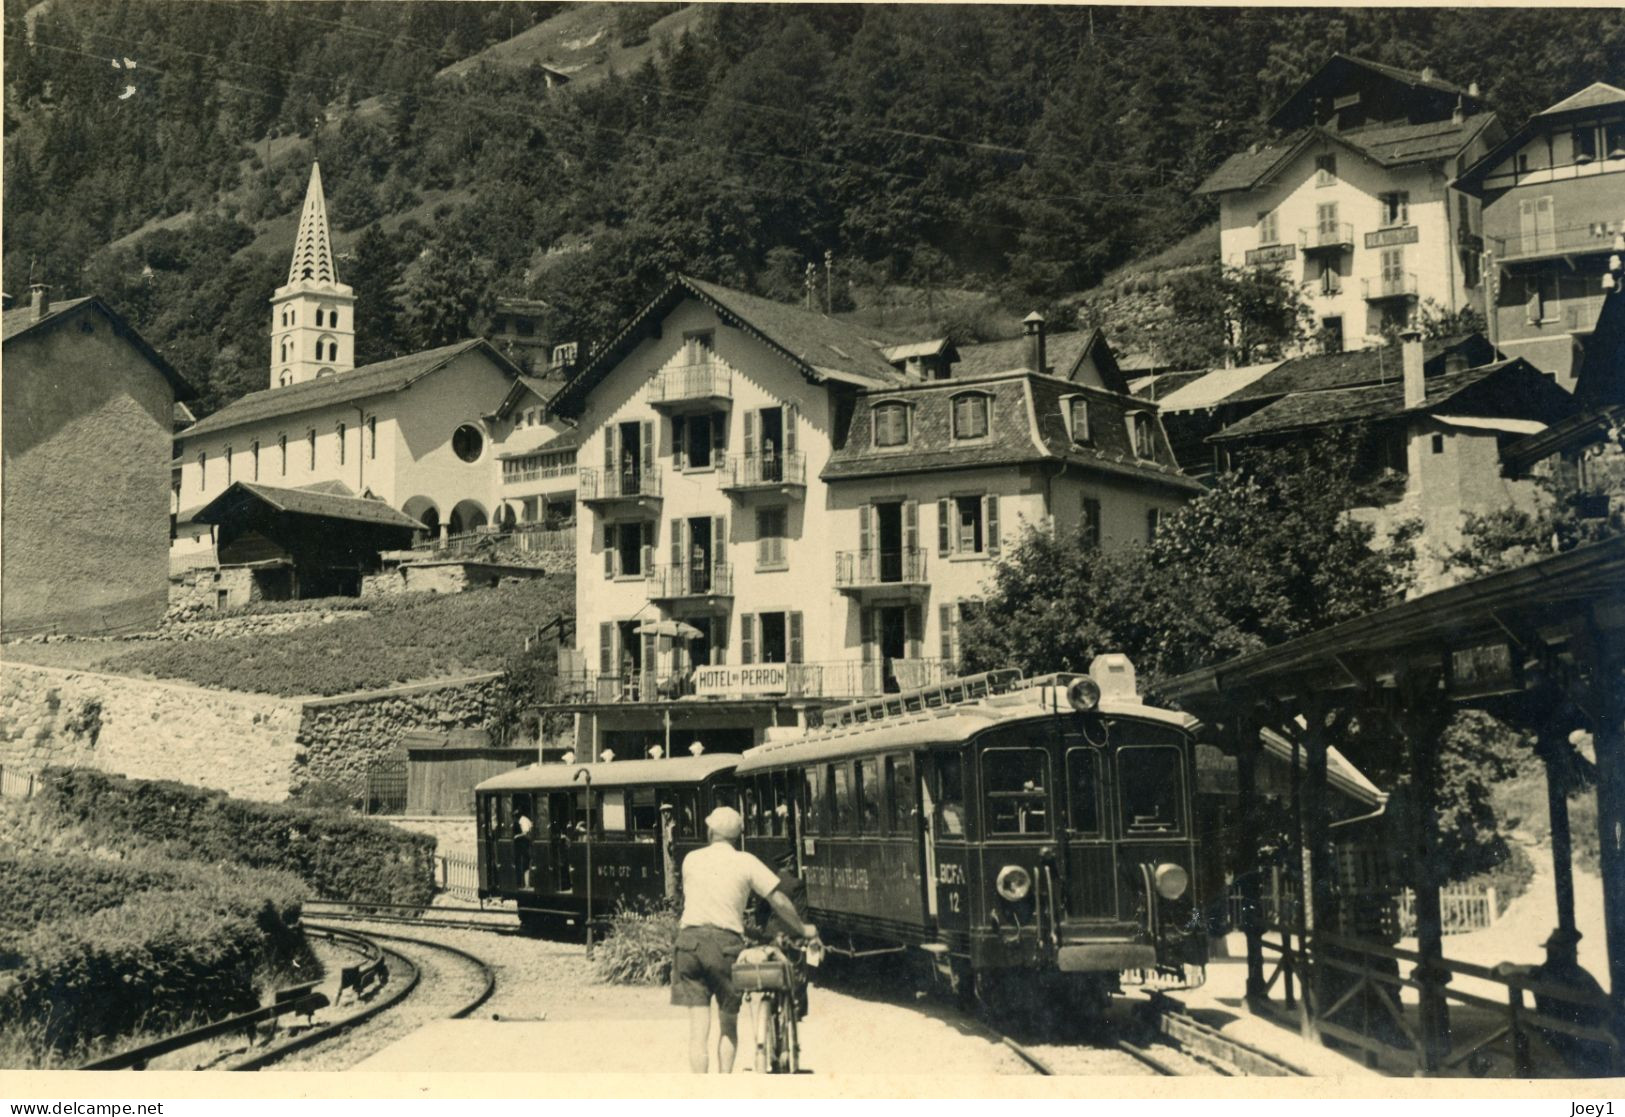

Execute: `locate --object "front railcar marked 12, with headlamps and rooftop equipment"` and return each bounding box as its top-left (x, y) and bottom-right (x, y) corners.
top-left (733, 655), bottom-right (1207, 1008)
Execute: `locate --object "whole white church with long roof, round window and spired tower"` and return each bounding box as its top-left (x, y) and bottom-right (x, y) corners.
top-left (172, 166), bottom-right (565, 585)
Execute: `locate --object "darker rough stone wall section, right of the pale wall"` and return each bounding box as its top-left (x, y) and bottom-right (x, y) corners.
top-left (291, 672), bottom-right (502, 793)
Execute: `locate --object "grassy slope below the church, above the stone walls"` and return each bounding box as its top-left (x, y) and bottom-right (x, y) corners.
top-left (95, 577), bottom-right (575, 696)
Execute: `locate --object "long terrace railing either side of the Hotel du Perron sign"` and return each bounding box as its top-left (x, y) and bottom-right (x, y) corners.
top-left (548, 657), bottom-right (957, 704)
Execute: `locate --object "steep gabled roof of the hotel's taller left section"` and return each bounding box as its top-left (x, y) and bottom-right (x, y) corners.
top-left (553, 275), bottom-right (908, 410)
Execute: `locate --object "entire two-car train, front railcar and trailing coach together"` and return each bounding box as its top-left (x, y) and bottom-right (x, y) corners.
top-left (476, 657), bottom-right (1207, 1006)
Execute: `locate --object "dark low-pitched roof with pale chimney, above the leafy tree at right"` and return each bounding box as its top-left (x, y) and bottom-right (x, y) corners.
top-left (1207, 358), bottom-right (1575, 442)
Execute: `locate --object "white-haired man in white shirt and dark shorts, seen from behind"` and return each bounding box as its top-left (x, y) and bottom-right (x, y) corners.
top-left (671, 806), bottom-right (817, 1075)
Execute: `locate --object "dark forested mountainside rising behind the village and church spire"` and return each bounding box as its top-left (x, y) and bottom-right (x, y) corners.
top-left (3, 0), bottom-right (1625, 410)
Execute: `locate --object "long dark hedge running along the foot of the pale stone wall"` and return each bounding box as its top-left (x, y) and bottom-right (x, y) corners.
top-left (37, 767), bottom-right (436, 904)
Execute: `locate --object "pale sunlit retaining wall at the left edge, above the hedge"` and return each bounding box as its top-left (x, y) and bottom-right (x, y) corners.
top-left (0, 662), bottom-right (301, 802)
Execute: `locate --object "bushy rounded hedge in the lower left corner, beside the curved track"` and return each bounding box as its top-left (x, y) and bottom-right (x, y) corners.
top-left (0, 857), bottom-right (307, 1054)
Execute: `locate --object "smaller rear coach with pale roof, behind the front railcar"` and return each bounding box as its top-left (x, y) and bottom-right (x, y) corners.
top-left (475, 753), bottom-right (739, 933)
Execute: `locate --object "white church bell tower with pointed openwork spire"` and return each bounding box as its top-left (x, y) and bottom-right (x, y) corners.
top-left (271, 163), bottom-right (356, 389)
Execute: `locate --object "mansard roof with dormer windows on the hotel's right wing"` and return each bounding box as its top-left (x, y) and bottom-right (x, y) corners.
top-left (821, 372), bottom-right (1196, 488)
